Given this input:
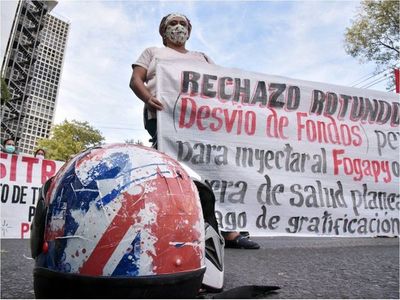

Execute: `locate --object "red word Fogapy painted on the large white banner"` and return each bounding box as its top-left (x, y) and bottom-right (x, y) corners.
top-left (332, 149), bottom-right (392, 183)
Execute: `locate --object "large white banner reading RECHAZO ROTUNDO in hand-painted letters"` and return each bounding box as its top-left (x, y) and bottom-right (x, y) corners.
top-left (157, 60), bottom-right (400, 237)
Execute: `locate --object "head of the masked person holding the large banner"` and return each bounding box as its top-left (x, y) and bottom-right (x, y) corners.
top-left (159, 13), bottom-right (192, 46)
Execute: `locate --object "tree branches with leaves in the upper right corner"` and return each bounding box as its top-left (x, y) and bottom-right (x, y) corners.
top-left (345, 0), bottom-right (400, 88)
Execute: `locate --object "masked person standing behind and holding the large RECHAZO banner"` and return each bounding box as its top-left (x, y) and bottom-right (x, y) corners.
top-left (129, 13), bottom-right (260, 249)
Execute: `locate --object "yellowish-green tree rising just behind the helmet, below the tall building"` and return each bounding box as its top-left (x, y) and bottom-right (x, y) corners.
top-left (38, 120), bottom-right (104, 161)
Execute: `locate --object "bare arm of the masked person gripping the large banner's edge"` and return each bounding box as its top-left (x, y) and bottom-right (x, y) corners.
top-left (129, 65), bottom-right (163, 111)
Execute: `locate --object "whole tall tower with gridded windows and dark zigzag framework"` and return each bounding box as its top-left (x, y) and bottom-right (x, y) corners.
top-left (1, 0), bottom-right (69, 154)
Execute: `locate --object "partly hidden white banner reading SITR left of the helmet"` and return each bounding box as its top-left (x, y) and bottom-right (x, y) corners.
top-left (0, 152), bottom-right (64, 238)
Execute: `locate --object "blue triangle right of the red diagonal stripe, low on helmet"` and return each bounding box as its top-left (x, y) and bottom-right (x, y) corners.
top-left (112, 232), bottom-right (140, 276)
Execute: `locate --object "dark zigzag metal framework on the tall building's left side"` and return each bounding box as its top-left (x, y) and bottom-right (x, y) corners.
top-left (1, 0), bottom-right (57, 142)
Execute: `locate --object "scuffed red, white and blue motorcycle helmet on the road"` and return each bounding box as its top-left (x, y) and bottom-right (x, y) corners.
top-left (31, 144), bottom-right (208, 298)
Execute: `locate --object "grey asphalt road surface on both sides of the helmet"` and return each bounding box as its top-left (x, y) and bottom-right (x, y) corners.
top-left (1, 237), bottom-right (399, 299)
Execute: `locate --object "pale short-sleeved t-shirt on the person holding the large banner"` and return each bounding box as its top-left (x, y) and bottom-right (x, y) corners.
top-left (132, 47), bottom-right (214, 123)
